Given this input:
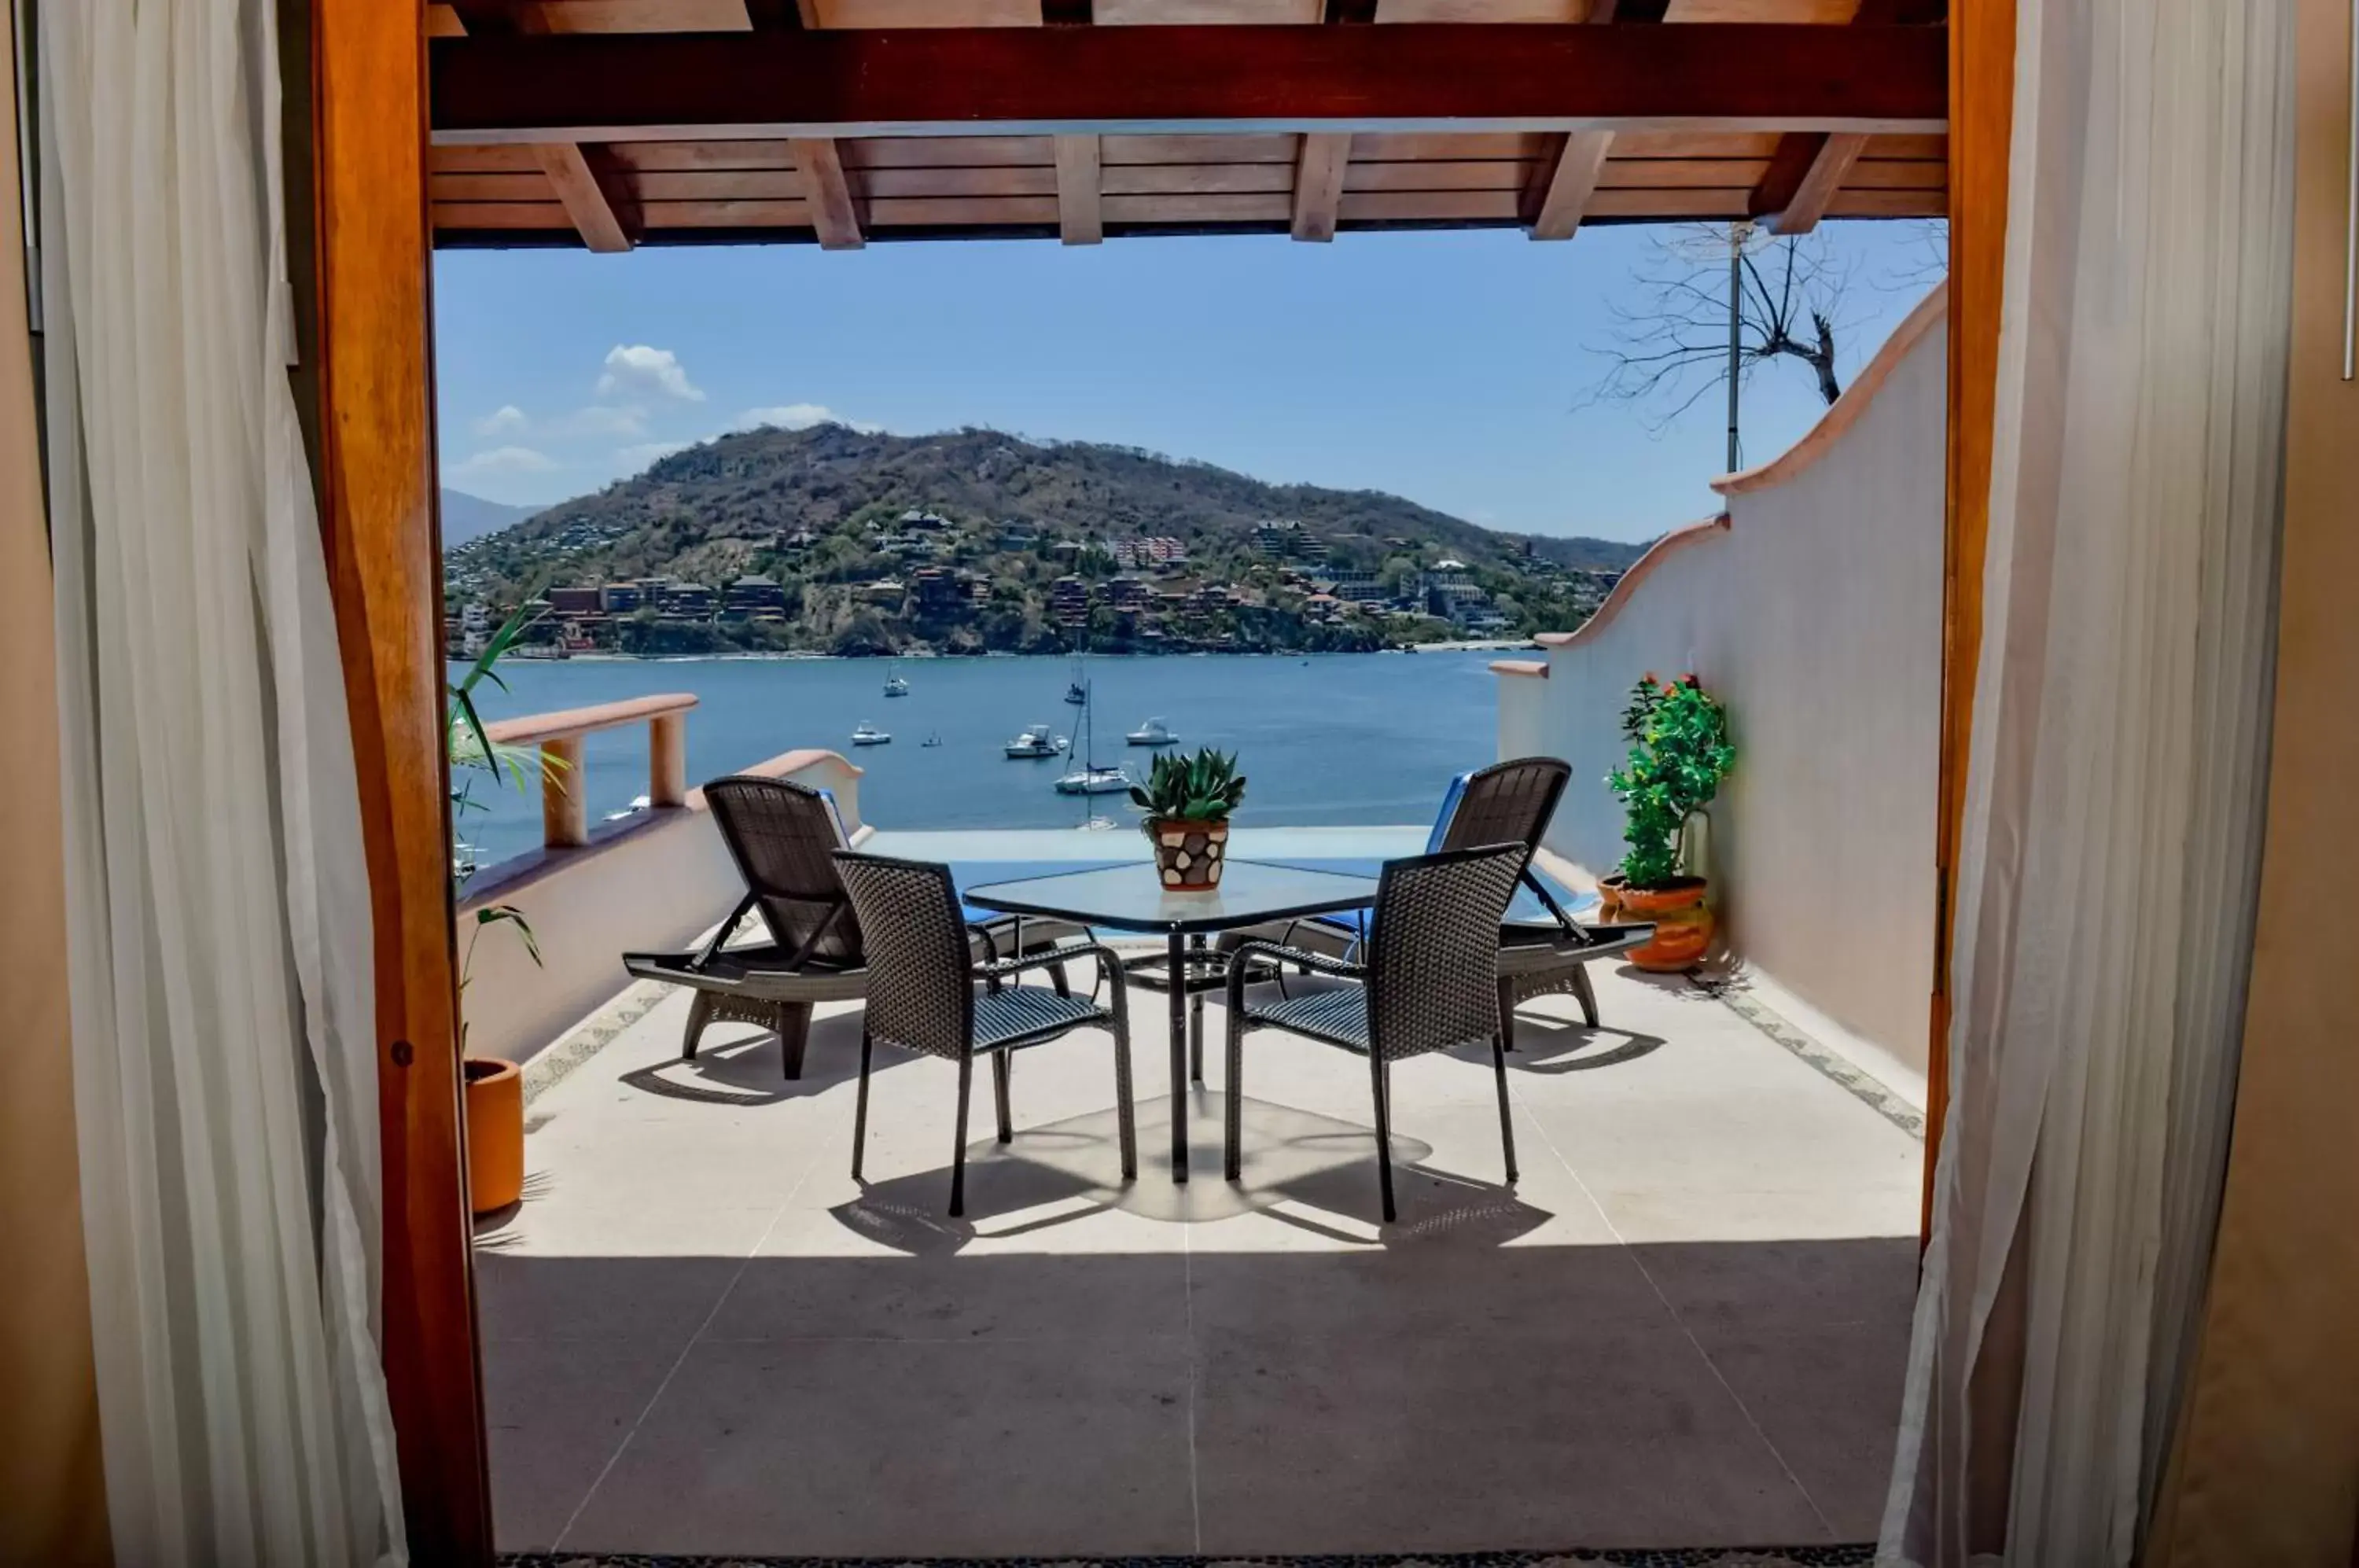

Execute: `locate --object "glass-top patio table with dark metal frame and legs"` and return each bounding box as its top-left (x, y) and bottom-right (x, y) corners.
top-left (965, 860), bottom-right (1375, 1181)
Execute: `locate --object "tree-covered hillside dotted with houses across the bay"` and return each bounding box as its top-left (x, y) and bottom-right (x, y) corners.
top-left (446, 425), bottom-right (1642, 653)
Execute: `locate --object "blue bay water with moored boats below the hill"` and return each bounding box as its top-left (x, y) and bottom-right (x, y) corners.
top-left (460, 653), bottom-right (1498, 865)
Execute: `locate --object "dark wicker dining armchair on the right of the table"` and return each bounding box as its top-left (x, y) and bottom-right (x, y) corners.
top-left (1224, 844), bottom-right (1531, 1224)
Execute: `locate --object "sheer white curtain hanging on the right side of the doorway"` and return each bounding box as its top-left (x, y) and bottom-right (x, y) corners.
top-left (1882, 0), bottom-right (2293, 1566)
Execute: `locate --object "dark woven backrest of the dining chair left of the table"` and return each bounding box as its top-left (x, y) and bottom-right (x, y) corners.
top-left (835, 851), bottom-right (974, 1061)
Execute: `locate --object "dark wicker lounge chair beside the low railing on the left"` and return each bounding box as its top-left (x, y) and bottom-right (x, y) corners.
top-left (623, 776), bottom-right (1090, 1080)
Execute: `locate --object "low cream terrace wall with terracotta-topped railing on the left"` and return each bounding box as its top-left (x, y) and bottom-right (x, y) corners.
top-left (458, 696), bottom-right (868, 1061)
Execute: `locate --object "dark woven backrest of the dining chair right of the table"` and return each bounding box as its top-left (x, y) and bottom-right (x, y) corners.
top-left (1368, 844), bottom-right (1531, 1061)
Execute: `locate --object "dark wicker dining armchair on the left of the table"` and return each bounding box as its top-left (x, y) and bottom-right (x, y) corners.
top-left (835, 848), bottom-right (1139, 1219)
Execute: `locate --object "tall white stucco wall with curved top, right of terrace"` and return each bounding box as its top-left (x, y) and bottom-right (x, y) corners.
top-left (1498, 287), bottom-right (1946, 1089)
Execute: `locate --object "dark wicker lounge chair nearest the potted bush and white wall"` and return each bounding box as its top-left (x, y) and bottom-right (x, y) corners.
top-left (1222, 757), bottom-right (1654, 1051)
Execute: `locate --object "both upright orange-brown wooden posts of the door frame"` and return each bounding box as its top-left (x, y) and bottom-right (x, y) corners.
top-left (309, 0), bottom-right (2015, 1563)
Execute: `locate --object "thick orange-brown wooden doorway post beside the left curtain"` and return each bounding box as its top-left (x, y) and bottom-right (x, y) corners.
top-left (314, 0), bottom-right (493, 1568)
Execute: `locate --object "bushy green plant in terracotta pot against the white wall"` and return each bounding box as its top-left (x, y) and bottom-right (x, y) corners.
top-left (1602, 675), bottom-right (1736, 971)
